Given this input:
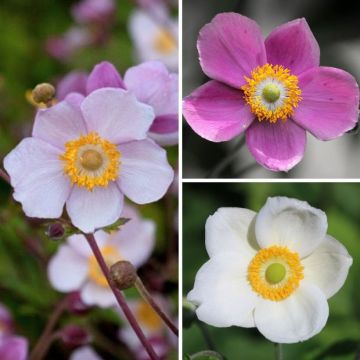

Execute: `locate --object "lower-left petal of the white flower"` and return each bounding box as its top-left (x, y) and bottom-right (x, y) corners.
top-left (187, 253), bottom-right (258, 327)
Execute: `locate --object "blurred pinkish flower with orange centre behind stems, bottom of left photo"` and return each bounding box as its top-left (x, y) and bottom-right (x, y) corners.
top-left (119, 294), bottom-right (174, 360)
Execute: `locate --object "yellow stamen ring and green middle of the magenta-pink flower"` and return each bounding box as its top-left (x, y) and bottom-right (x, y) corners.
top-left (241, 64), bottom-right (301, 123)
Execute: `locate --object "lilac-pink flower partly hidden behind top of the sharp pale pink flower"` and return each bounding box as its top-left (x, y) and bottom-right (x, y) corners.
top-left (57, 61), bottom-right (178, 145)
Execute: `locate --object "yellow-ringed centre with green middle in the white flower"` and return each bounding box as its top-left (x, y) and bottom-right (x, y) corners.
top-left (248, 245), bottom-right (304, 301)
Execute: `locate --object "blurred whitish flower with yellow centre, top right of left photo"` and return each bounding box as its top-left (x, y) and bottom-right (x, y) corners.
top-left (129, 10), bottom-right (178, 71)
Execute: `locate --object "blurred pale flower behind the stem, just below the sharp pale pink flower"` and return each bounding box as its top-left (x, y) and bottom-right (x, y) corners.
top-left (48, 206), bottom-right (155, 307)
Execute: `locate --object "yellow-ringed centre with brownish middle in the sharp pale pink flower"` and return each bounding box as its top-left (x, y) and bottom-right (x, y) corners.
top-left (60, 132), bottom-right (121, 191)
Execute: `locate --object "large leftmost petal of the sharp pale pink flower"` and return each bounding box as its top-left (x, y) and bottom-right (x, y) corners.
top-left (4, 138), bottom-right (71, 219)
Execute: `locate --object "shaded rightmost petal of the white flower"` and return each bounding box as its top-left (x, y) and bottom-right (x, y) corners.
top-left (302, 235), bottom-right (352, 298)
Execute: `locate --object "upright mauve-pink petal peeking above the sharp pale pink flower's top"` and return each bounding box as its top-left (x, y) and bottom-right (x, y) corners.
top-left (86, 61), bottom-right (125, 94)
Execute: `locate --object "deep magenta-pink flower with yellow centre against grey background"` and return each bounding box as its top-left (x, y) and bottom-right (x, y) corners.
top-left (183, 13), bottom-right (359, 171)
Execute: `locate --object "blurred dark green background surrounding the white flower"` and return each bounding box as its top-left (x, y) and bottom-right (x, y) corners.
top-left (183, 183), bottom-right (360, 360)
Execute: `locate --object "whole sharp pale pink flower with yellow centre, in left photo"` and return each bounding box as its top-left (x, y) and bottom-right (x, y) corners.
top-left (4, 88), bottom-right (173, 233)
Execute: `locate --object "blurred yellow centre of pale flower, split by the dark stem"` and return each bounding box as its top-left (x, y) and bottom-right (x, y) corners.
top-left (88, 245), bottom-right (122, 287)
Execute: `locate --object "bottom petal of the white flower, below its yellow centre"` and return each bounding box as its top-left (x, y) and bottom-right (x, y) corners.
top-left (254, 281), bottom-right (329, 344)
